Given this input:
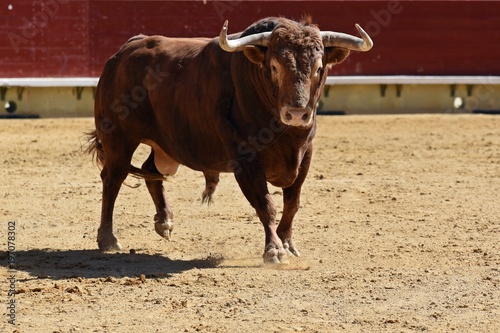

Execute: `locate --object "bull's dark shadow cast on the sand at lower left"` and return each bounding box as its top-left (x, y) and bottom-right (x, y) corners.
top-left (0, 249), bottom-right (221, 280)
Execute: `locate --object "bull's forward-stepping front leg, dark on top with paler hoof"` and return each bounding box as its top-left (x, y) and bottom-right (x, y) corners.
top-left (235, 163), bottom-right (287, 263)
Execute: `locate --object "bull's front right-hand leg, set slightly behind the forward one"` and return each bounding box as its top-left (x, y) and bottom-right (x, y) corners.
top-left (277, 145), bottom-right (312, 257)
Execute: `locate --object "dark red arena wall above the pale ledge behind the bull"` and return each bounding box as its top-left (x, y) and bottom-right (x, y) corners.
top-left (0, 0), bottom-right (500, 77)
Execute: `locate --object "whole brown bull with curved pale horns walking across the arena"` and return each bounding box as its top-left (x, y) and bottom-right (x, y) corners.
top-left (89, 18), bottom-right (372, 262)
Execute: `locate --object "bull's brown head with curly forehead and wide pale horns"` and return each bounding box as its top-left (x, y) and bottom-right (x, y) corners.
top-left (219, 19), bottom-right (373, 126)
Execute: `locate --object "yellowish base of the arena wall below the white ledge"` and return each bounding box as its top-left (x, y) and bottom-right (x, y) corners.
top-left (0, 77), bottom-right (500, 118)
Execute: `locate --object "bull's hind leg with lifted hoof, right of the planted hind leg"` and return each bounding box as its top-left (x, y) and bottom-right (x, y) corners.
top-left (142, 149), bottom-right (174, 240)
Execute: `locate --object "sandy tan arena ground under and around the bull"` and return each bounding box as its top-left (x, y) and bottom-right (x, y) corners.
top-left (0, 115), bottom-right (500, 333)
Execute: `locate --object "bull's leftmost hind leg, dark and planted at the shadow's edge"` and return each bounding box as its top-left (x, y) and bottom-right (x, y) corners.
top-left (97, 140), bottom-right (137, 251)
